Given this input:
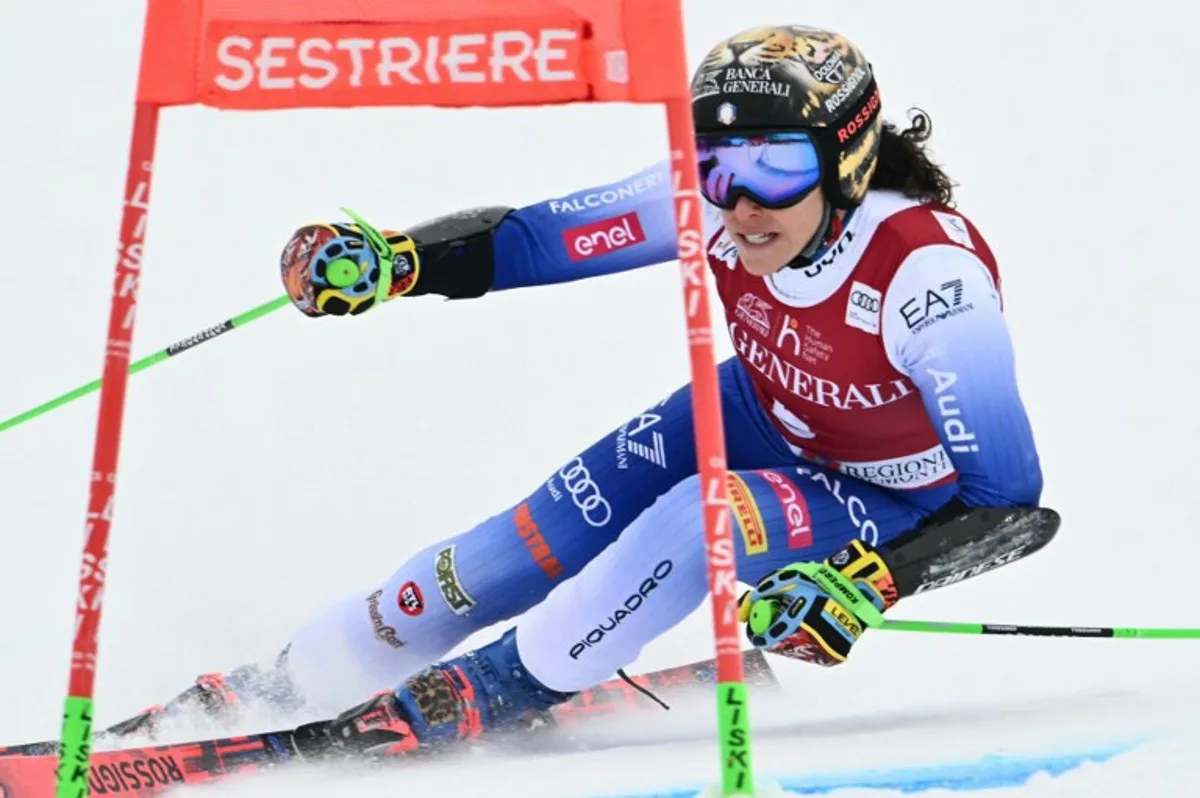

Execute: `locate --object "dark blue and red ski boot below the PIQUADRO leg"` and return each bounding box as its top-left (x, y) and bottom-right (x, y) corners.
top-left (329, 629), bottom-right (575, 756)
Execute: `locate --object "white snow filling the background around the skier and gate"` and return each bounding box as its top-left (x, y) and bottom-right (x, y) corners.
top-left (0, 0), bottom-right (1200, 798)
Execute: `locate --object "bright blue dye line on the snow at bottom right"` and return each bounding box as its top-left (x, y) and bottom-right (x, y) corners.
top-left (606, 740), bottom-right (1145, 798)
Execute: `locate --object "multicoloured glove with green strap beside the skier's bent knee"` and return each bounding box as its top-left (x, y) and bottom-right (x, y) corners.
top-left (738, 540), bottom-right (898, 666)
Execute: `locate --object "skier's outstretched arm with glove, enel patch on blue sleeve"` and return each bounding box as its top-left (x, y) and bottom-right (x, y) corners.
top-left (274, 162), bottom-right (677, 316)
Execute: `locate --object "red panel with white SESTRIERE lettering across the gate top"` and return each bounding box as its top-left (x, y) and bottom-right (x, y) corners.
top-left (203, 20), bottom-right (583, 106)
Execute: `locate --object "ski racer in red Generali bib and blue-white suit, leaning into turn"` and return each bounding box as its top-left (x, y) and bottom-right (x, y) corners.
top-left (138, 26), bottom-right (1042, 752)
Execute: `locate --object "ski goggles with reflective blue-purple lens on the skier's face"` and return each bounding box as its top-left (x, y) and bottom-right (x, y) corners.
top-left (696, 132), bottom-right (821, 210)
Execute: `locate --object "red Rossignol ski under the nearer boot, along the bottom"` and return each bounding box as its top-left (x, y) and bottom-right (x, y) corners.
top-left (0, 649), bottom-right (778, 798)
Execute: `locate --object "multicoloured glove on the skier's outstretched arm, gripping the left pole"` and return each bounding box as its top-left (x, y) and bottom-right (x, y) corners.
top-left (280, 209), bottom-right (421, 316)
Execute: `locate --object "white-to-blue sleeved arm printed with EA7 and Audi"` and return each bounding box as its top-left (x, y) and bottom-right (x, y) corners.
top-left (882, 245), bottom-right (1042, 506)
